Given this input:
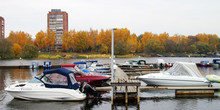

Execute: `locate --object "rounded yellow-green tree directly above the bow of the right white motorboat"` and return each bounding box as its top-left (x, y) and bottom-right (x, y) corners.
top-left (145, 40), bottom-right (165, 54)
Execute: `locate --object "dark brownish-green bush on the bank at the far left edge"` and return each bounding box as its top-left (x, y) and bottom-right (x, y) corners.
top-left (0, 38), bottom-right (14, 59)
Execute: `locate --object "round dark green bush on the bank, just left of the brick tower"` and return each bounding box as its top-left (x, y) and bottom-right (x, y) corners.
top-left (21, 44), bottom-right (38, 58)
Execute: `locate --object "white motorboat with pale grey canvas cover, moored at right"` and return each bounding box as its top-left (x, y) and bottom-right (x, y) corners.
top-left (137, 62), bottom-right (210, 86)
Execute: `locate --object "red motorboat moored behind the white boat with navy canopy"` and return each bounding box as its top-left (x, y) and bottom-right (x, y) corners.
top-left (61, 64), bottom-right (110, 86)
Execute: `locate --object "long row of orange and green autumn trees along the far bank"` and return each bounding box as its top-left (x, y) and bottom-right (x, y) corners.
top-left (0, 28), bottom-right (220, 59)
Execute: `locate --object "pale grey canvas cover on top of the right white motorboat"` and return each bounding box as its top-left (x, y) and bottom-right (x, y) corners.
top-left (164, 62), bottom-right (203, 78)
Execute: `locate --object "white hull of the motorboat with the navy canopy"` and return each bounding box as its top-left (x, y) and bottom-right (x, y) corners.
top-left (5, 85), bottom-right (86, 101)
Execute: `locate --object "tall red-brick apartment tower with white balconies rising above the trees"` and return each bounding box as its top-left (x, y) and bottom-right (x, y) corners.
top-left (47, 9), bottom-right (68, 50)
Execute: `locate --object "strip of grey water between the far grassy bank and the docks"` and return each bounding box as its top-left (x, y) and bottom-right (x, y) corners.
top-left (0, 57), bottom-right (216, 66)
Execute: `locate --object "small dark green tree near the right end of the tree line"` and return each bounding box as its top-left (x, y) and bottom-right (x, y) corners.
top-left (196, 42), bottom-right (211, 54)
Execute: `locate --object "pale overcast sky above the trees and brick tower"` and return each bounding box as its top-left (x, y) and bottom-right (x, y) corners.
top-left (0, 0), bottom-right (220, 38)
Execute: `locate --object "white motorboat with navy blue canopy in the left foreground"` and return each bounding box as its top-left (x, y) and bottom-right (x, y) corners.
top-left (5, 68), bottom-right (86, 101)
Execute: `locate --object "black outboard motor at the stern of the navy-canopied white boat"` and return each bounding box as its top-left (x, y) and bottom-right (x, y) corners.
top-left (79, 82), bottom-right (99, 97)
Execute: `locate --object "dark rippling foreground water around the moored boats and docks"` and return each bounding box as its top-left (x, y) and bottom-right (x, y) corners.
top-left (0, 58), bottom-right (220, 110)
